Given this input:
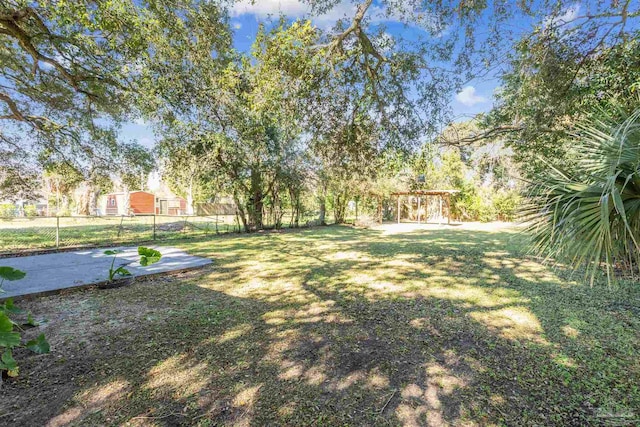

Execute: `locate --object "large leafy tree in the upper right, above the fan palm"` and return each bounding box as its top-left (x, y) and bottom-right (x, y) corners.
top-left (443, 1), bottom-right (640, 178)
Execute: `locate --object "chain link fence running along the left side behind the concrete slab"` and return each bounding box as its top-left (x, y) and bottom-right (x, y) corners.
top-left (0, 215), bottom-right (330, 254)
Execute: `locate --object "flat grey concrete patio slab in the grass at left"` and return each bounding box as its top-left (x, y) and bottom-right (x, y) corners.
top-left (0, 246), bottom-right (211, 298)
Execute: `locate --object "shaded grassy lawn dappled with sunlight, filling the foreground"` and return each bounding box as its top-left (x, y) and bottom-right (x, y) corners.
top-left (0, 227), bottom-right (640, 426)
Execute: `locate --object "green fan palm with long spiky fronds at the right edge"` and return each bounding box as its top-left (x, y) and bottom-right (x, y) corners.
top-left (525, 109), bottom-right (640, 285)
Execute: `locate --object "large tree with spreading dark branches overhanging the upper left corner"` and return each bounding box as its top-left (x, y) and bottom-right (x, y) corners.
top-left (0, 0), bottom-right (228, 201)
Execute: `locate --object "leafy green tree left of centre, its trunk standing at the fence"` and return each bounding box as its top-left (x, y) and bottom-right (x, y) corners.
top-left (155, 20), bottom-right (316, 230)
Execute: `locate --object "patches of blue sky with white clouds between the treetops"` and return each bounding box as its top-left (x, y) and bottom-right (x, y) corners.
top-left (121, 0), bottom-right (580, 147)
